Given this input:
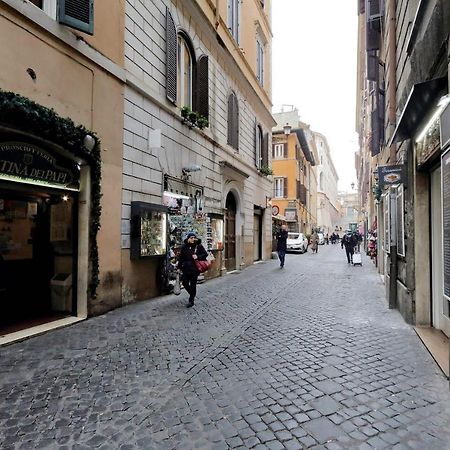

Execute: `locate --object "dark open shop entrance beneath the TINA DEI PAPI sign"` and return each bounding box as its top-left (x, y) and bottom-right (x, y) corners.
top-left (0, 182), bottom-right (78, 334)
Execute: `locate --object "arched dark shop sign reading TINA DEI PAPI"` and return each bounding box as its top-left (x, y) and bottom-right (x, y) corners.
top-left (0, 142), bottom-right (79, 189)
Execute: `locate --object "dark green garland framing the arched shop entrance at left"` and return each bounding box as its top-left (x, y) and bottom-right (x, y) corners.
top-left (0, 89), bottom-right (102, 298)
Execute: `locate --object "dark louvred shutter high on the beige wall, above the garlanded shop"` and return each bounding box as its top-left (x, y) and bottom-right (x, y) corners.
top-left (58, 0), bottom-right (94, 34)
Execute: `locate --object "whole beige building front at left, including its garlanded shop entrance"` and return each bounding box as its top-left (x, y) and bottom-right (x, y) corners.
top-left (0, 0), bottom-right (124, 334)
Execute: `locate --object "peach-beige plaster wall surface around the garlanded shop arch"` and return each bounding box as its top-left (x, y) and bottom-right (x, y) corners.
top-left (0, 6), bottom-right (123, 314)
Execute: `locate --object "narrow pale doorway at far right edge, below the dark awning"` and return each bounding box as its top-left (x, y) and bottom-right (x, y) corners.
top-left (431, 167), bottom-right (450, 336)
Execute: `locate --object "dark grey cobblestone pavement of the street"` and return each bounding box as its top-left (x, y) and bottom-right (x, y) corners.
top-left (0, 245), bottom-right (450, 450)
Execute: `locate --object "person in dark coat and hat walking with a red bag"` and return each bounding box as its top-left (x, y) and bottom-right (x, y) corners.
top-left (178, 232), bottom-right (208, 308)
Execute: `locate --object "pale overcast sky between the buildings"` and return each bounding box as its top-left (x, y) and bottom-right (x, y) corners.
top-left (272, 0), bottom-right (358, 191)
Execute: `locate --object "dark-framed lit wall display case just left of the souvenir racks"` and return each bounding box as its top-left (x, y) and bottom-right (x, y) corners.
top-left (130, 202), bottom-right (167, 259)
